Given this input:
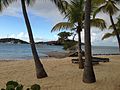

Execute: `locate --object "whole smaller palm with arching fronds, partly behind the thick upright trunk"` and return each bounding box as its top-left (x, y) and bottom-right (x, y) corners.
top-left (52, 0), bottom-right (106, 68)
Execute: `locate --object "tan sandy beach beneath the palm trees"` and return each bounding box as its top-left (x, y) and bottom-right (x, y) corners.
top-left (0, 55), bottom-right (120, 90)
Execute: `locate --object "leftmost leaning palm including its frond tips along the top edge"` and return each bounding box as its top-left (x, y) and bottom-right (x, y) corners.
top-left (0, 0), bottom-right (47, 78)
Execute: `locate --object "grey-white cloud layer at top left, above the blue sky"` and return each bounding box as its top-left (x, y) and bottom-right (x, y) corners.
top-left (1, 0), bottom-right (63, 24)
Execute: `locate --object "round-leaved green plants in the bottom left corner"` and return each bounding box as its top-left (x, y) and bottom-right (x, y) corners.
top-left (1, 81), bottom-right (40, 90)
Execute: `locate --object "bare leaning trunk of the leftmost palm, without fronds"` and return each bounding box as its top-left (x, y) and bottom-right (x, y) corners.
top-left (21, 0), bottom-right (47, 78)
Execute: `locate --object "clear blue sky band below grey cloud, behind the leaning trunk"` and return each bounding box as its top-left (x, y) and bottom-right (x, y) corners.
top-left (0, 15), bottom-right (58, 40)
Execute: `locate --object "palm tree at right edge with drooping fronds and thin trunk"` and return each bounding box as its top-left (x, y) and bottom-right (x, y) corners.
top-left (94, 0), bottom-right (120, 51)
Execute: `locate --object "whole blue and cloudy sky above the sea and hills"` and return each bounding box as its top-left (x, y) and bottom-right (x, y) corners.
top-left (0, 0), bottom-right (118, 46)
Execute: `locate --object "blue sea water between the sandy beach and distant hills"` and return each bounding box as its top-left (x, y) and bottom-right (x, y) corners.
top-left (0, 44), bottom-right (119, 60)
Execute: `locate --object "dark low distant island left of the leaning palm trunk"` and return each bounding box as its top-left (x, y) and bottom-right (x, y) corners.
top-left (0, 38), bottom-right (29, 44)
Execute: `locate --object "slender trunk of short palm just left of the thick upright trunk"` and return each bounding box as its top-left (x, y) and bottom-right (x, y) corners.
top-left (77, 25), bottom-right (84, 69)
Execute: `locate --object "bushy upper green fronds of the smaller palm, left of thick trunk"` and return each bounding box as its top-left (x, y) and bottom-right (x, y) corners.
top-left (65, 0), bottom-right (85, 23)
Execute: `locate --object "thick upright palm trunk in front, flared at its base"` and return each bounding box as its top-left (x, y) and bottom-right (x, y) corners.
top-left (83, 0), bottom-right (96, 83)
